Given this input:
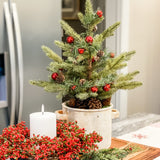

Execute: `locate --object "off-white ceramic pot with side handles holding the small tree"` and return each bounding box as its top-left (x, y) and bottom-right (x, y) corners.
top-left (55, 103), bottom-right (119, 149)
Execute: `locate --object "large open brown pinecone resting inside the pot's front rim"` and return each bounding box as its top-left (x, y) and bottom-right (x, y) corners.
top-left (88, 98), bottom-right (102, 109)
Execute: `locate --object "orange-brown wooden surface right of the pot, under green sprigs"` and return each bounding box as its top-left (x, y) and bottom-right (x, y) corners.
top-left (111, 138), bottom-right (160, 160)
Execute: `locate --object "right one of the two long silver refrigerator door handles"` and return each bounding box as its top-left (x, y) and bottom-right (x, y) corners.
top-left (11, 3), bottom-right (24, 122)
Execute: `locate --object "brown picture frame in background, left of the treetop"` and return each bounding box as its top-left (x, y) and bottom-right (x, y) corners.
top-left (62, 0), bottom-right (80, 19)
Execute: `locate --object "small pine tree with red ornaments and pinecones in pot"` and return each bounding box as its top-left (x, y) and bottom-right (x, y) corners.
top-left (30, 0), bottom-right (142, 109)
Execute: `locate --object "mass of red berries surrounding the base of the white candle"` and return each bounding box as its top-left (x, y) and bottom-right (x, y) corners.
top-left (0, 121), bottom-right (102, 160)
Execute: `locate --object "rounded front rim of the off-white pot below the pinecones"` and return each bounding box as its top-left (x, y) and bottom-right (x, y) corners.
top-left (62, 102), bottom-right (113, 112)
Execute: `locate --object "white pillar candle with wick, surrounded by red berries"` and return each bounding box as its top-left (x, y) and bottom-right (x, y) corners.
top-left (30, 105), bottom-right (57, 138)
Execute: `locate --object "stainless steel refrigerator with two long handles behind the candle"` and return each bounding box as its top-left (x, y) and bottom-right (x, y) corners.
top-left (0, 0), bottom-right (61, 130)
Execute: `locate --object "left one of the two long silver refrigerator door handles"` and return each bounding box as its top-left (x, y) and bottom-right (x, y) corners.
top-left (4, 2), bottom-right (16, 125)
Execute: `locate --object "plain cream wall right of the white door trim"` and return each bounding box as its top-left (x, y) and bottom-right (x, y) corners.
top-left (128, 0), bottom-right (160, 114)
